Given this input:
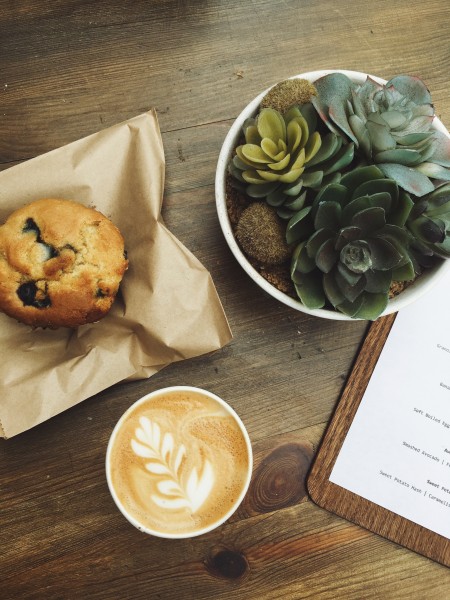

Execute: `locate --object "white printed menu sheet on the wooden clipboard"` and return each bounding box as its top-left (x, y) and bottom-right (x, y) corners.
top-left (330, 271), bottom-right (450, 539)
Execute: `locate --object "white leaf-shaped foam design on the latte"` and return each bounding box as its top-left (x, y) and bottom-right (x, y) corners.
top-left (131, 417), bottom-right (214, 513)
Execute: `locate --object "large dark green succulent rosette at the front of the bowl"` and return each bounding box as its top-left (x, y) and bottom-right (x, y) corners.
top-left (287, 165), bottom-right (420, 320)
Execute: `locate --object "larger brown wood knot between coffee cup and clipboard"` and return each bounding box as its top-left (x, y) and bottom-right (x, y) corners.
top-left (249, 444), bottom-right (312, 513)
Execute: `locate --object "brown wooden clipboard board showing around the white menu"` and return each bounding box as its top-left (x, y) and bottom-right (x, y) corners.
top-left (307, 314), bottom-right (450, 567)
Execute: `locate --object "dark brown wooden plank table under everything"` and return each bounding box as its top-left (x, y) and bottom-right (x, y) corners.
top-left (0, 0), bottom-right (450, 600)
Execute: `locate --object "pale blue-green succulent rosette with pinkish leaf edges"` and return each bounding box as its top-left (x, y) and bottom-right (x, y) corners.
top-left (312, 73), bottom-right (450, 196)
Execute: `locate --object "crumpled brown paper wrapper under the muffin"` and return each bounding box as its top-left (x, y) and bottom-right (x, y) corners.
top-left (0, 111), bottom-right (231, 437)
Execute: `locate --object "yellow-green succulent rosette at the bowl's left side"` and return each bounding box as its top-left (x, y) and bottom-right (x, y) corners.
top-left (229, 103), bottom-right (354, 218)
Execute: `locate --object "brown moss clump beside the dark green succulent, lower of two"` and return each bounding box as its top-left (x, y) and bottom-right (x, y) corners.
top-left (236, 202), bottom-right (291, 265)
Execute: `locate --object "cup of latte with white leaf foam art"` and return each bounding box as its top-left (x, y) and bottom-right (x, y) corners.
top-left (106, 387), bottom-right (252, 538)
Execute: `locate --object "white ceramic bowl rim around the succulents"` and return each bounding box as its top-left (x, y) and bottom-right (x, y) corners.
top-left (215, 69), bottom-right (450, 321)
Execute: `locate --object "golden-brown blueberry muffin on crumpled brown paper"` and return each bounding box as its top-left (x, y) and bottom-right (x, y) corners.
top-left (0, 199), bottom-right (128, 329)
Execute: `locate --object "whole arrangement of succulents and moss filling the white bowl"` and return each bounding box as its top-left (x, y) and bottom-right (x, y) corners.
top-left (228, 73), bottom-right (450, 320)
